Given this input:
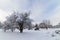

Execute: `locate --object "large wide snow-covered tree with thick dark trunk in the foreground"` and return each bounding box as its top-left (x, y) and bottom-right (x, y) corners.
top-left (4, 12), bottom-right (32, 32)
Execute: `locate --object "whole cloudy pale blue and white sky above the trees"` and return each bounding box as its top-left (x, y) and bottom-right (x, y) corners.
top-left (0, 0), bottom-right (60, 25)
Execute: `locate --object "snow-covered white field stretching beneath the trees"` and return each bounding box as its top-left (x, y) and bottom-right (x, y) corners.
top-left (0, 29), bottom-right (60, 40)
